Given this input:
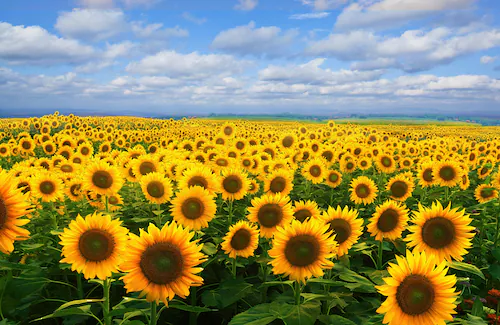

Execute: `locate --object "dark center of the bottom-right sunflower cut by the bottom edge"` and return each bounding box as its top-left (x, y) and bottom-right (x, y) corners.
top-left (396, 274), bottom-right (435, 316)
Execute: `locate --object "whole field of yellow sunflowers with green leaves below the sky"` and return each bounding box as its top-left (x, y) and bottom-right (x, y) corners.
top-left (0, 112), bottom-right (500, 325)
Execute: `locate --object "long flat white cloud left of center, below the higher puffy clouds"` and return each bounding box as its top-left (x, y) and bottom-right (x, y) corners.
top-left (126, 51), bottom-right (249, 78)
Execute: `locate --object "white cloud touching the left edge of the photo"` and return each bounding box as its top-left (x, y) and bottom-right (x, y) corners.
top-left (0, 22), bottom-right (97, 65)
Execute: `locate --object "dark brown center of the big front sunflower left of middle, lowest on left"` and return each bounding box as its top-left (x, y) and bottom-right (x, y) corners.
top-left (139, 243), bottom-right (184, 285)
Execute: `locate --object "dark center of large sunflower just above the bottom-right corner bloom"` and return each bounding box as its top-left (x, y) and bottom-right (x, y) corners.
top-left (422, 217), bottom-right (455, 249)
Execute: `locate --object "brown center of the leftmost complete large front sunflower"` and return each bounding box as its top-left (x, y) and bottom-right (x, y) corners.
top-left (78, 229), bottom-right (115, 262)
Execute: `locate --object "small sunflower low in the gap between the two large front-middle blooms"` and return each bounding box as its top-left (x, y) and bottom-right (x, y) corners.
top-left (221, 220), bottom-right (259, 258)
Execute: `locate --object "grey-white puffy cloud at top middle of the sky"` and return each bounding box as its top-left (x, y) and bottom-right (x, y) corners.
top-left (211, 21), bottom-right (298, 56)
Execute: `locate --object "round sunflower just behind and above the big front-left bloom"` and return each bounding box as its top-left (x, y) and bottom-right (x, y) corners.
top-left (171, 186), bottom-right (217, 230)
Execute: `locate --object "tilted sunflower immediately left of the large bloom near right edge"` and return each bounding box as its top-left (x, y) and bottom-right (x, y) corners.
top-left (366, 200), bottom-right (408, 240)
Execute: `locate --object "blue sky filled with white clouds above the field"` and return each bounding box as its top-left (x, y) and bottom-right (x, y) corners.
top-left (0, 0), bottom-right (500, 117)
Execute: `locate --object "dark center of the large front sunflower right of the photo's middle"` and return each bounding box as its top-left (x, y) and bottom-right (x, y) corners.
top-left (285, 235), bottom-right (320, 266)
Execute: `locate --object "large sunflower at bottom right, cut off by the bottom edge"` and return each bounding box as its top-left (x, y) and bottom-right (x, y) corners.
top-left (376, 251), bottom-right (458, 325)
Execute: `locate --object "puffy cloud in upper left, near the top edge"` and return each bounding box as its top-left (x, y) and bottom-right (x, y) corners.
top-left (55, 9), bottom-right (128, 41)
